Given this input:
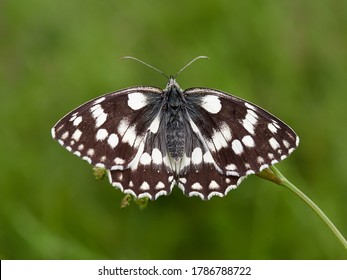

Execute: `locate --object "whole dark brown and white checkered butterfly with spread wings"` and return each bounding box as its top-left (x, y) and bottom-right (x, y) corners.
top-left (51, 57), bottom-right (299, 200)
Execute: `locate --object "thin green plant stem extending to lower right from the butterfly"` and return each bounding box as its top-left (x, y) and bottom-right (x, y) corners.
top-left (270, 166), bottom-right (347, 250)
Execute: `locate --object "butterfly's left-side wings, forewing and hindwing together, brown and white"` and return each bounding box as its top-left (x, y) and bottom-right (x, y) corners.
top-left (52, 87), bottom-right (177, 198)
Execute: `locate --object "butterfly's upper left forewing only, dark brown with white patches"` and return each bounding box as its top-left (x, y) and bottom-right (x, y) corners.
top-left (52, 87), bottom-right (162, 169)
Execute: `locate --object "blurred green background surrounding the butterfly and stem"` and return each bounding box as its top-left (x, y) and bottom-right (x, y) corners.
top-left (0, 0), bottom-right (347, 259)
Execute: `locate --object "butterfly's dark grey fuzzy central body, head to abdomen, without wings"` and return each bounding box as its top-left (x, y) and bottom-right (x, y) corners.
top-left (163, 78), bottom-right (185, 161)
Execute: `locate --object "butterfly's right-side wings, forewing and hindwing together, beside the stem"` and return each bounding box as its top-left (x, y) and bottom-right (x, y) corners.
top-left (181, 88), bottom-right (299, 199)
